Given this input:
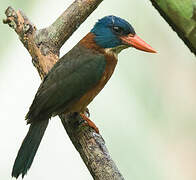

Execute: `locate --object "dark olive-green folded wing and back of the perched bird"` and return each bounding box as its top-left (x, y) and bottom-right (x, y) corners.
top-left (26, 47), bottom-right (106, 122)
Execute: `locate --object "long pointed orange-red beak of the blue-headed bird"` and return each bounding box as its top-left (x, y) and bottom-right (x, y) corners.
top-left (120, 34), bottom-right (156, 53)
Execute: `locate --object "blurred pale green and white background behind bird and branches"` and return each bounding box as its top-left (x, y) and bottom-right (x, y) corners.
top-left (0, 0), bottom-right (196, 180)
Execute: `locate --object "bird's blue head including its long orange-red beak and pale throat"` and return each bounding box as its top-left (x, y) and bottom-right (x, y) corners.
top-left (91, 16), bottom-right (156, 53)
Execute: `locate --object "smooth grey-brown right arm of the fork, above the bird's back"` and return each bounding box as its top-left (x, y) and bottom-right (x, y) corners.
top-left (40, 0), bottom-right (102, 49)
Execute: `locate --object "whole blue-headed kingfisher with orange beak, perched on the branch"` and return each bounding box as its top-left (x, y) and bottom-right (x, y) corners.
top-left (12, 15), bottom-right (156, 179)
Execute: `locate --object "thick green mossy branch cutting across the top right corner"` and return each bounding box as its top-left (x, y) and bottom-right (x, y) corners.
top-left (150, 0), bottom-right (196, 55)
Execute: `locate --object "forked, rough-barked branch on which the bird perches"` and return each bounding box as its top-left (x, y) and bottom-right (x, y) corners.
top-left (3, 0), bottom-right (124, 180)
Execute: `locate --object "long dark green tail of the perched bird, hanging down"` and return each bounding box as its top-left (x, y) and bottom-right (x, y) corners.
top-left (12, 120), bottom-right (49, 178)
